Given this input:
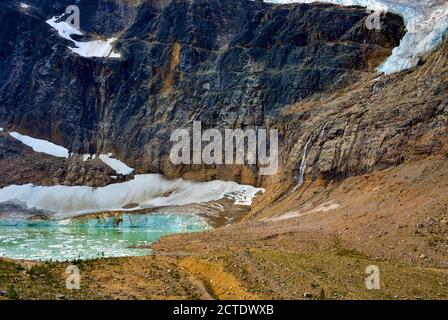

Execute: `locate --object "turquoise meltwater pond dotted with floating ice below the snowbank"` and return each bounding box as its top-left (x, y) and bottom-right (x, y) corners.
top-left (0, 214), bottom-right (209, 261)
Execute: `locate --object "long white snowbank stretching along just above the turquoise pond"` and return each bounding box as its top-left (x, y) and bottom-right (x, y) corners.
top-left (0, 174), bottom-right (264, 217)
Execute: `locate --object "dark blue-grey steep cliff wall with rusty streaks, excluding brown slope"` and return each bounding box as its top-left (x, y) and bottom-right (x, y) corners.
top-left (0, 0), bottom-right (404, 184)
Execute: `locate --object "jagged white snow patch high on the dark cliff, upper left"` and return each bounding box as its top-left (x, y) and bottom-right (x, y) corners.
top-left (46, 17), bottom-right (121, 58)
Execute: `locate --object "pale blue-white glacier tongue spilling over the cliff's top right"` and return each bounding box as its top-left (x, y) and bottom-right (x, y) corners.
top-left (264, 0), bottom-right (448, 75)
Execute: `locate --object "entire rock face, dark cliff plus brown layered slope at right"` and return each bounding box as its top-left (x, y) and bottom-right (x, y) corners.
top-left (4, 0), bottom-right (438, 191)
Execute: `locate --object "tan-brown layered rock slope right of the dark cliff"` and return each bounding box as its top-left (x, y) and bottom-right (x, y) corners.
top-left (272, 35), bottom-right (448, 198)
